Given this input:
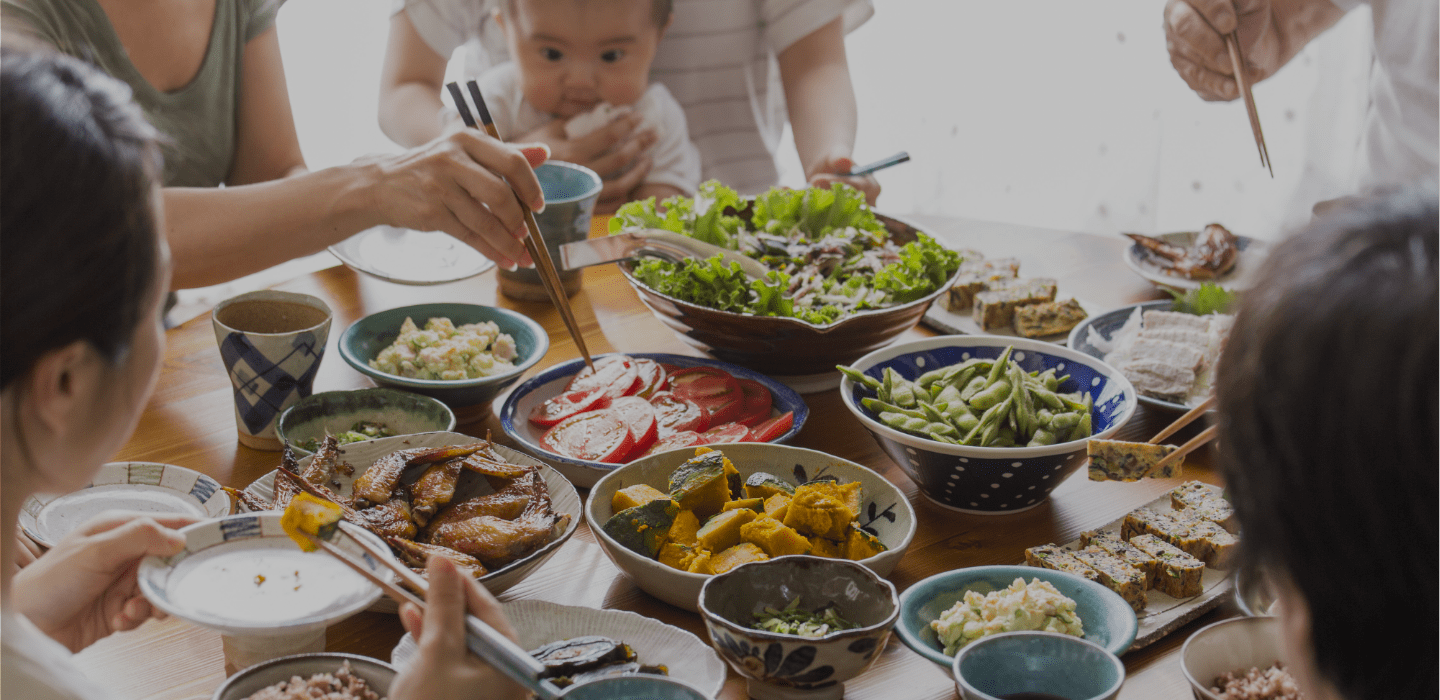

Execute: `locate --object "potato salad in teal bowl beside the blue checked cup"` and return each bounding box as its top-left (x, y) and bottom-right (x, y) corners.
top-left (370, 318), bottom-right (517, 380)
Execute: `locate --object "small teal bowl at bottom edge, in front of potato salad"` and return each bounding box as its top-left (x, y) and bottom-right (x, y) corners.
top-left (950, 632), bottom-right (1125, 700)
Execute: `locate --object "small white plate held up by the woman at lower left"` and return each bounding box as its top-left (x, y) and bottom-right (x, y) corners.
top-left (138, 511), bottom-right (393, 637)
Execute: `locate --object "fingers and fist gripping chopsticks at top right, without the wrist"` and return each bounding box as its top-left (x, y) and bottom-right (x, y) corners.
top-left (1165, 0), bottom-right (1297, 101)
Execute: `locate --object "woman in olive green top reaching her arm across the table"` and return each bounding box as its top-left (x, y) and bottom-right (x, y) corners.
top-left (0, 0), bottom-right (547, 288)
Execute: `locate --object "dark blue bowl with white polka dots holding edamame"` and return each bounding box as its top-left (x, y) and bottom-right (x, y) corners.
top-left (840, 336), bottom-right (1136, 516)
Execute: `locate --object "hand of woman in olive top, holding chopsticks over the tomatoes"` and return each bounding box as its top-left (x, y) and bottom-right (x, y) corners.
top-left (366, 130), bottom-right (550, 268)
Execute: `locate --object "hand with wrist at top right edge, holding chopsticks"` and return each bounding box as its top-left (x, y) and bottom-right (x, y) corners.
top-left (1165, 0), bottom-right (1344, 101)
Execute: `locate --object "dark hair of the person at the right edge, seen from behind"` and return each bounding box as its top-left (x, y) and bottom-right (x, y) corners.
top-left (1217, 190), bottom-right (1440, 700)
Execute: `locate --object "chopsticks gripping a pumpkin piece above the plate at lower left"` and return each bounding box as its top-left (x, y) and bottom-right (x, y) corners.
top-left (302, 523), bottom-right (560, 700)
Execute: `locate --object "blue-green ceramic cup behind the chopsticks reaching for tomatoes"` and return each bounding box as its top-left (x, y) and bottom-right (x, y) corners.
top-left (500, 160), bottom-right (600, 301)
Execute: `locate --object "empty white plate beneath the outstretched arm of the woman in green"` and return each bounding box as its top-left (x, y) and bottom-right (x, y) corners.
top-left (330, 226), bottom-right (495, 285)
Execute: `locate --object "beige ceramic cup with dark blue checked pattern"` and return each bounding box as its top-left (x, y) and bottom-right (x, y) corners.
top-left (210, 291), bottom-right (331, 451)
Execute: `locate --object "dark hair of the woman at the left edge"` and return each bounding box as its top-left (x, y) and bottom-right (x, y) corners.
top-left (0, 48), bottom-right (160, 387)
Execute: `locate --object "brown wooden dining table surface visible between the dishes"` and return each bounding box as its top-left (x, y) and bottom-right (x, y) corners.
top-left (78, 216), bottom-right (1237, 700)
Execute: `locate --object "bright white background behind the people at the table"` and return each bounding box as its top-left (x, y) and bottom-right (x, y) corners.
top-left (279, 0), bottom-right (1369, 239)
